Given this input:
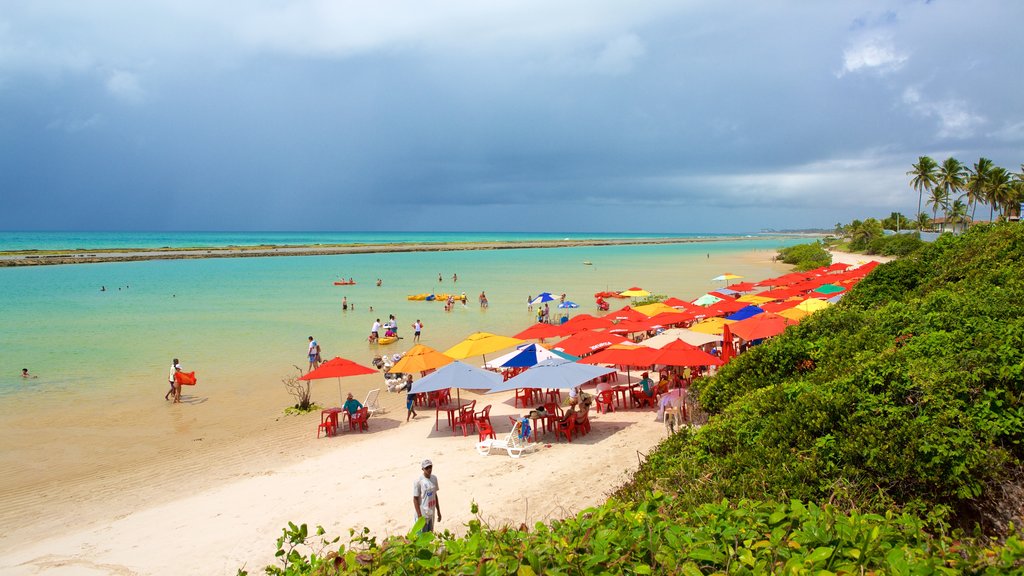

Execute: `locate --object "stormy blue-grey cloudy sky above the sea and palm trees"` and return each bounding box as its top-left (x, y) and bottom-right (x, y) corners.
top-left (0, 0), bottom-right (1024, 233)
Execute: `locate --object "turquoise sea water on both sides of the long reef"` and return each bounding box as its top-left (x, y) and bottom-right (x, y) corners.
top-left (0, 233), bottom-right (801, 402)
